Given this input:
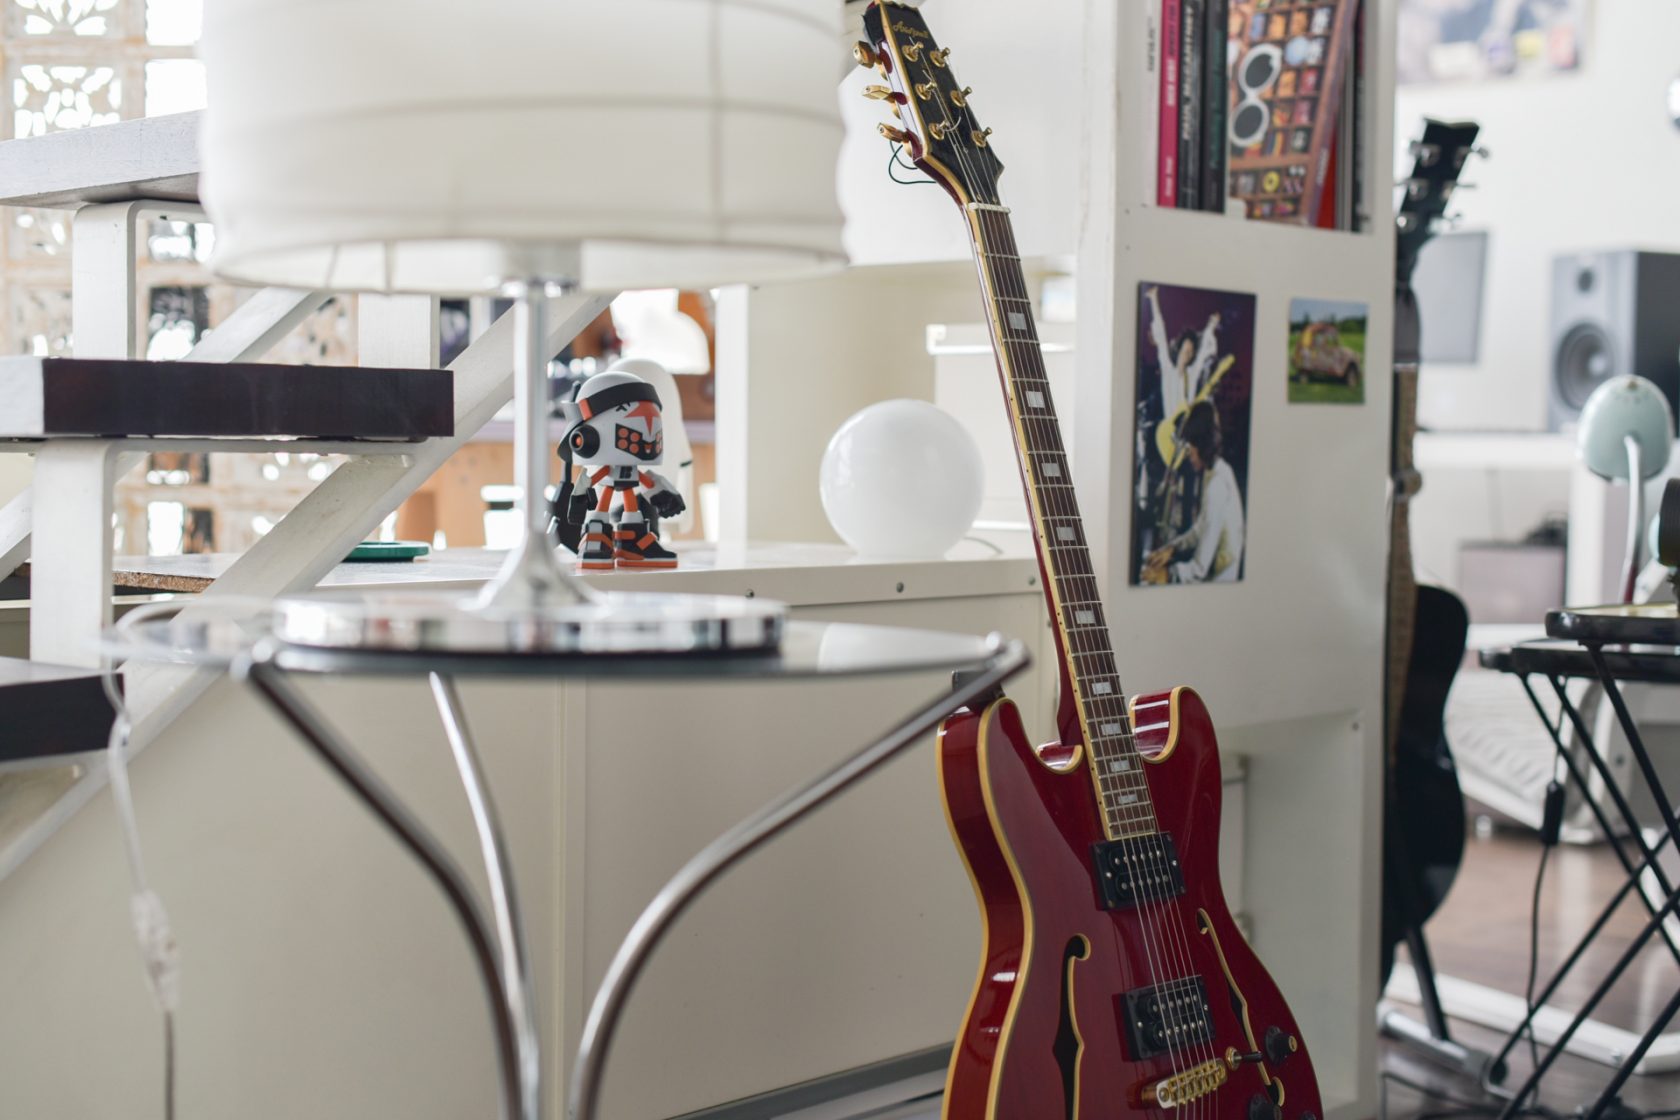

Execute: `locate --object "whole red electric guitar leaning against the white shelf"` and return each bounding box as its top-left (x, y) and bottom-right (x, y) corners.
top-left (857, 2), bottom-right (1323, 1120)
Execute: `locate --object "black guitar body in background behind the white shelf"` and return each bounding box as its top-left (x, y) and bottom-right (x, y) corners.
top-left (1383, 586), bottom-right (1470, 982)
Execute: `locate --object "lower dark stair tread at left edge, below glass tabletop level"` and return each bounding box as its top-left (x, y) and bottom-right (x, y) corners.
top-left (0, 657), bottom-right (114, 764)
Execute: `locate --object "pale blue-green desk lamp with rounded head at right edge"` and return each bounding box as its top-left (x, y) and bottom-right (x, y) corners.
top-left (1576, 376), bottom-right (1675, 603)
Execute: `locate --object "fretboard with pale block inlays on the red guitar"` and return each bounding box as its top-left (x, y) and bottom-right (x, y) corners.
top-left (968, 203), bottom-right (1158, 840)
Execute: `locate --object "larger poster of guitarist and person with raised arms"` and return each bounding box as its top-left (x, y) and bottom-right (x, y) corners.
top-left (1131, 284), bottom-right (1255, 584)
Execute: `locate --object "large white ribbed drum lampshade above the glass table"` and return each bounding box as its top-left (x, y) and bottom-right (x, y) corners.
top-left (200, 0), bottom-right (845, 294)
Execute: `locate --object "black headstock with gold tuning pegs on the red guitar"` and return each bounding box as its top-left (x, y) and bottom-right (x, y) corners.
top-left (853, 0), bottom-right (1003, 203)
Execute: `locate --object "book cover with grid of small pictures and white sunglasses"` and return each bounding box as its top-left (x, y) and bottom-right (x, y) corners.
top-left (1226, 0), bottom-right (1359, 225)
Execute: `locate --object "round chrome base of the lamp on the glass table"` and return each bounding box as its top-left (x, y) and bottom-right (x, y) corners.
top-left (270, 591), bottom-right (786, 657)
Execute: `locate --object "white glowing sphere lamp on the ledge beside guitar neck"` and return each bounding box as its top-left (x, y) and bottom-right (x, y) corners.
top-left (820, 400), bottom-right (984, 559)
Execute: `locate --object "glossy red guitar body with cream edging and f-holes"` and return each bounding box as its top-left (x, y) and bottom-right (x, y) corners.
top-left (939, 688), bottom-right (1324, 1120)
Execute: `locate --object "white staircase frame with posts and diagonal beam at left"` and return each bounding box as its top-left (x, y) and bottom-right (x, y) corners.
top-left (0, 113), bottom-right (610, 877)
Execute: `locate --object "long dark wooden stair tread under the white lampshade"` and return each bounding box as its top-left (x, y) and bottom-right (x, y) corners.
top-left (0, 356), bottom-right (455, 440)
